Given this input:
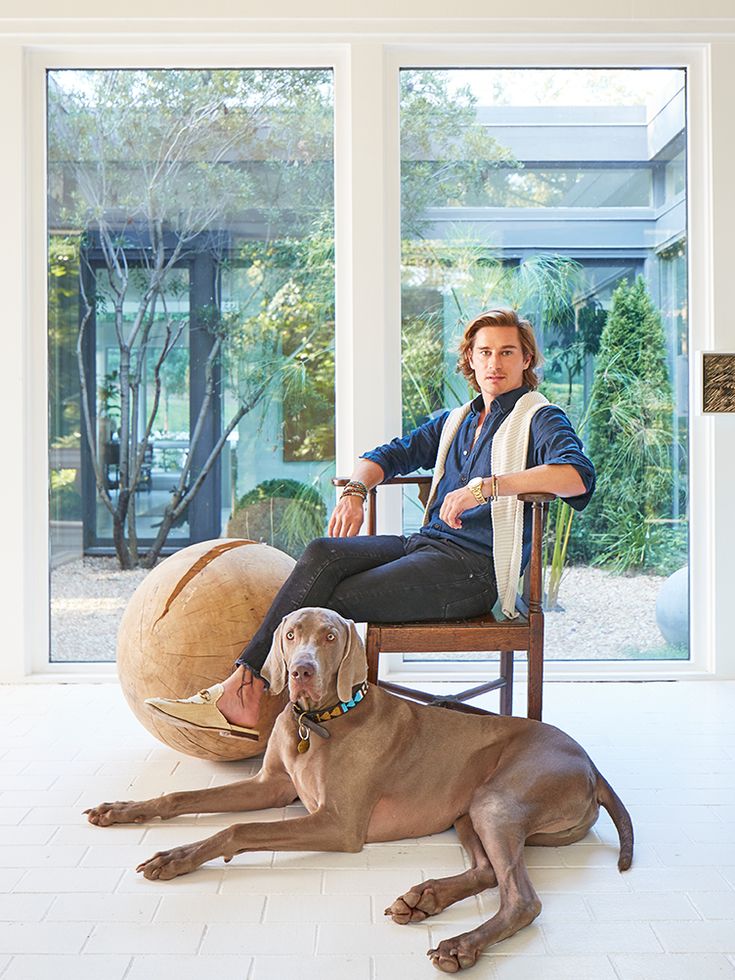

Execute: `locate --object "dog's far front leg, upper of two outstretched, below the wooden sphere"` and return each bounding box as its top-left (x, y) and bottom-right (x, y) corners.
top-left (84, 769), bottom-right (296, 827)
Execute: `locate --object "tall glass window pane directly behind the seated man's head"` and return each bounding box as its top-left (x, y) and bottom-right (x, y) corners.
top-left (401, 69), bottom-right (689, 660)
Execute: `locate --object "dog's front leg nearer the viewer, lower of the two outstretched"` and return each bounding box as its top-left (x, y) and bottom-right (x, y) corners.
top-left (136, 808), bottom-right (367, 880)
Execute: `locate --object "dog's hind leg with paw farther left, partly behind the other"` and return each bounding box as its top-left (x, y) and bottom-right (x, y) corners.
top-left (385, 813), bottom-right (497, 925)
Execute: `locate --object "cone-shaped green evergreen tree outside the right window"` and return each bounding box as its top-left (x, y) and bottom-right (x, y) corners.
top-left (582, 276), bottom-right (673, 570)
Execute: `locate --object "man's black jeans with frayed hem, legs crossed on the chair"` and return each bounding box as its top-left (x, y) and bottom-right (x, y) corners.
top-left (236, 534), bottom-right (497, 674)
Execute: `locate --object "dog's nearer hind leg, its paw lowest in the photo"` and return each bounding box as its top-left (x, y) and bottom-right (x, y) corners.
top-left (427, 789), bottom-right (541, 973)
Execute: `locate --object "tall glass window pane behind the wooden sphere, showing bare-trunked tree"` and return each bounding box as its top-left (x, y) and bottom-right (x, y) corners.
top-left (47, 69), bottom-right (334, 660)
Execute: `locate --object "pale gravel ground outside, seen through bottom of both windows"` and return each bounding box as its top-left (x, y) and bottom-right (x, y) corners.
top-left (51, 558), bottom-right (681, 662)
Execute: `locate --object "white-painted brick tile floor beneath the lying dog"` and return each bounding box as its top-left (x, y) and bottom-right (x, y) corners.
top-left (0, 682), bottom-right (735, 980)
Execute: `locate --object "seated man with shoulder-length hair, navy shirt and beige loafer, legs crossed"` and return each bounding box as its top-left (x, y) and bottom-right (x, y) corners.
top-left (147, 309), bottom-right (595, 737)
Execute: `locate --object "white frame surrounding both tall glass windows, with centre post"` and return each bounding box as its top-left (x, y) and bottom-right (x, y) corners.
top-left (11, 31), bottom-right (720, 681)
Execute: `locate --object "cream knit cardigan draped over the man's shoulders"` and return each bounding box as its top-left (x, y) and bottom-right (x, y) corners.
top-left (424, 391), bottom-right (550, 619)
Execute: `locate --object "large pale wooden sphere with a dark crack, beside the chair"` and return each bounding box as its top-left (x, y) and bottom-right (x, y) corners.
top-left (117, 538), bottom-right (295, 761)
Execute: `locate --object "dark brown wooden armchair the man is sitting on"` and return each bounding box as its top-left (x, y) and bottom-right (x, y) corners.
top-left (332, 476), bottom-right (555, 721)
